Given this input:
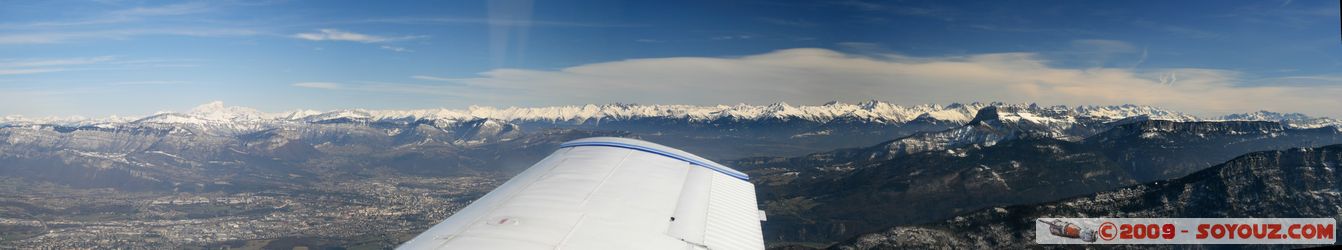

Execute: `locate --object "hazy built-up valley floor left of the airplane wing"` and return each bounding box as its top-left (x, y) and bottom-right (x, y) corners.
top-left (0, 176), bottom-right (499, 249)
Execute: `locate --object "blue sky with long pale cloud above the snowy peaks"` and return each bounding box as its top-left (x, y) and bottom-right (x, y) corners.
top-left (0, 0), bottom-right (1342, 117)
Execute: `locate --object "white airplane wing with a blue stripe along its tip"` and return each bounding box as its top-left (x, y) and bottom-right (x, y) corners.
top-left (397, 137), bottom-right (764, 250)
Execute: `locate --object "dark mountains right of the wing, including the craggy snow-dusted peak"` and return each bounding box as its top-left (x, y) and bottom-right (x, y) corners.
top-left (734, 108), bottom-right (1342, 243)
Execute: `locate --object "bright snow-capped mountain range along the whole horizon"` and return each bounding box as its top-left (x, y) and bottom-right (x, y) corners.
top-left (0, 101), bottom-right (1342, 128)
